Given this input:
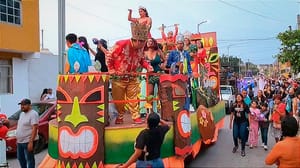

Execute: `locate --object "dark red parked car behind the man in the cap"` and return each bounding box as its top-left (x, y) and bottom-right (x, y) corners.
top-left (6, 102), bottom-right (56, 154)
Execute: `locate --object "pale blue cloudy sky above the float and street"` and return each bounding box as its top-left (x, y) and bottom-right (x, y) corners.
top-left (39, 0), bottom-right (300, 64)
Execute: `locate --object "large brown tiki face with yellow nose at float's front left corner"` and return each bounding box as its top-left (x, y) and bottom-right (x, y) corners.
top-left (57, 75), bottom-right (108, 168)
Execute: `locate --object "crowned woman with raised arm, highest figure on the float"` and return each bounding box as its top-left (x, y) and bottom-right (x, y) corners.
top-left (128, 6), bottom-right (152, 38)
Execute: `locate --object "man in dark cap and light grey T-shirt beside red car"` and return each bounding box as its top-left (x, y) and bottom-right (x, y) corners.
top-left (16, 99), bottom-right (39, 168)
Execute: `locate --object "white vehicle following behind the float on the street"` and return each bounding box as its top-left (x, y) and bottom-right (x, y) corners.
top-left (220, 85), bottom-right (235, 114)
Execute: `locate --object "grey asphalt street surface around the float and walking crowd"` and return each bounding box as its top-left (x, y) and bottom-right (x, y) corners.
top-left (8, 115), bottom-right (276, 168)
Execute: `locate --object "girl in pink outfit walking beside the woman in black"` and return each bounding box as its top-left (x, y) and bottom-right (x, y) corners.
top-left (248, 101), bottom-right (260, 148)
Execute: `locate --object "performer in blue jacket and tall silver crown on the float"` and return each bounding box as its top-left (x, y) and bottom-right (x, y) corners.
top-left (166, 34), bottom-right (192, 110)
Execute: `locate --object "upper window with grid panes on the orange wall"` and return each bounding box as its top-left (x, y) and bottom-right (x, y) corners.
top-left (0, 0), bottom-right (21, 25)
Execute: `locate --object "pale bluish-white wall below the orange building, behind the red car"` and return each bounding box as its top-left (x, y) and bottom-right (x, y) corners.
top-left (0, 52), bottom-right (58, 116)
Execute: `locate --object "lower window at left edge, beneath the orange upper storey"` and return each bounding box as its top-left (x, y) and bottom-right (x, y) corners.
top-left (0, 59), bottom-right (13, 94)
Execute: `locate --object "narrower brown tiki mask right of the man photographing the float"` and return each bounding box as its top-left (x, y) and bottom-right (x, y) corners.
top-left (160, 74), bottom-right (192, 156)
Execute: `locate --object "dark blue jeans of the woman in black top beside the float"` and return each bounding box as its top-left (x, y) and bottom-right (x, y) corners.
top-left (232, 122), bottom-right (248, 150)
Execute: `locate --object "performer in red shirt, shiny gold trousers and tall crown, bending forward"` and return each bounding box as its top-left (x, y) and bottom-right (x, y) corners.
top-left (107, 23), bottom-right (153, 124)
